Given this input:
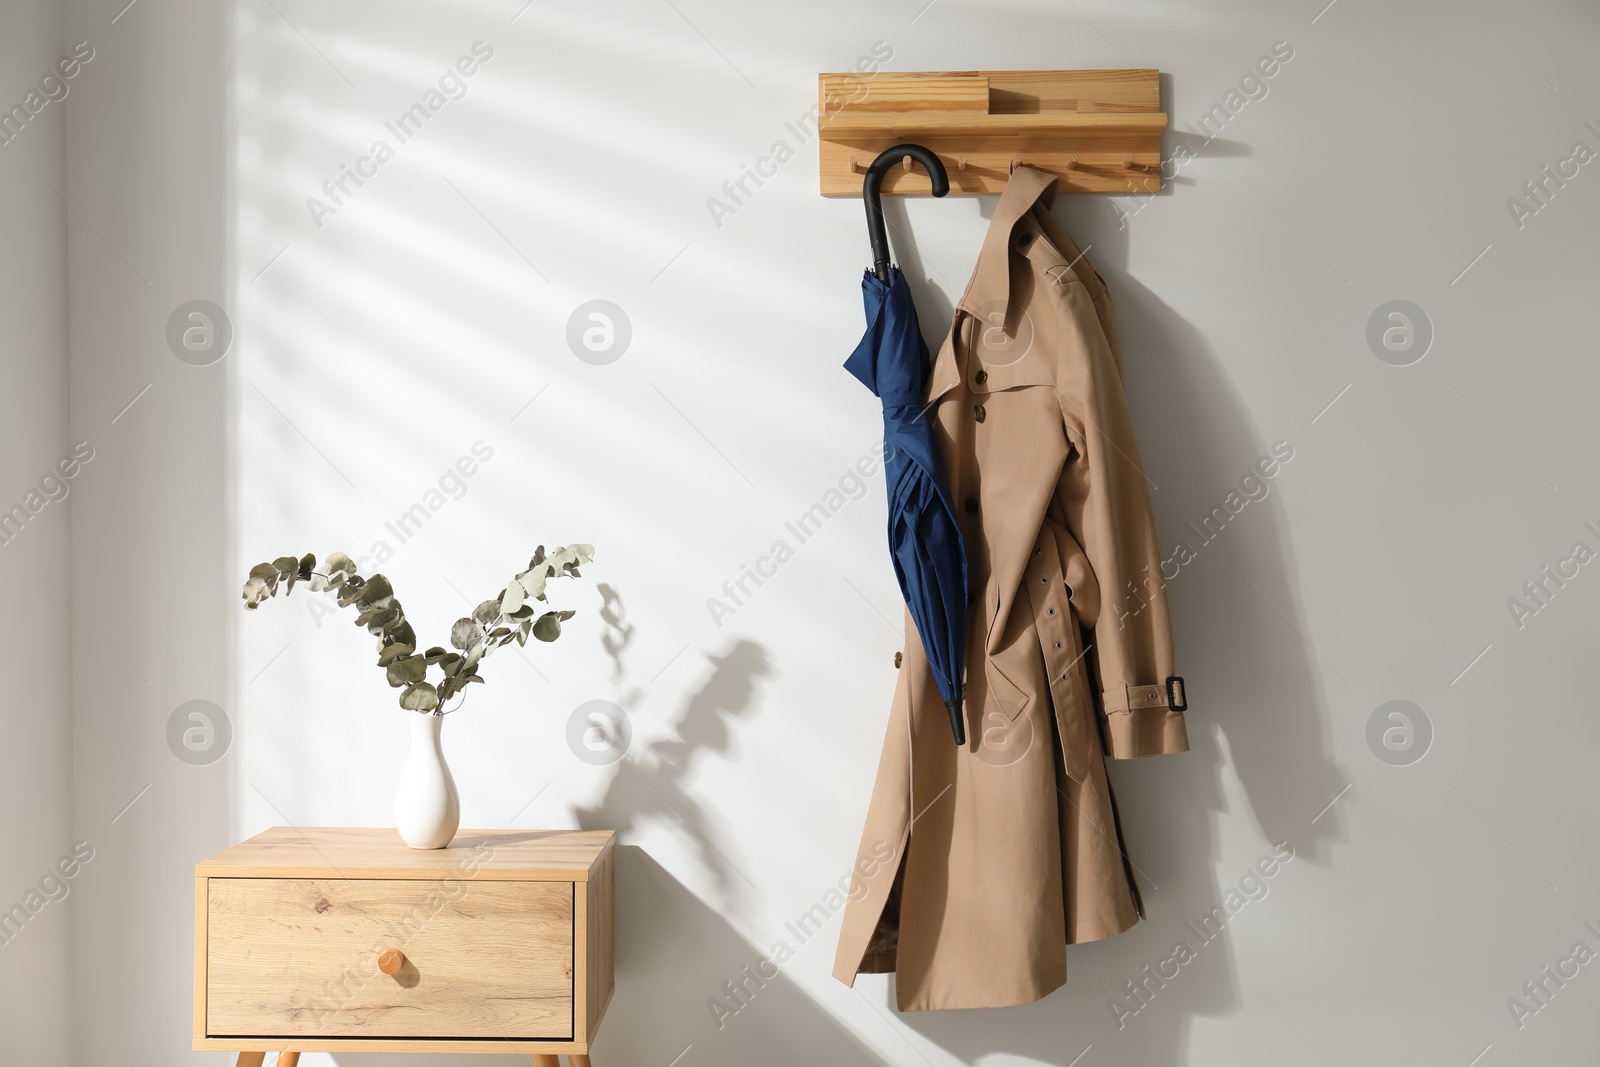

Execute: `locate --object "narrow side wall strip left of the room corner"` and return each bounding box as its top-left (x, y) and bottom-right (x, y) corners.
top-left (0, 0), bottom-right (74, 1064)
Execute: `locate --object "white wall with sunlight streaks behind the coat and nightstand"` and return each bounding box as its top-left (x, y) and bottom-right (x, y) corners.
top-left (18, 0), bottom-right (1600, 1067)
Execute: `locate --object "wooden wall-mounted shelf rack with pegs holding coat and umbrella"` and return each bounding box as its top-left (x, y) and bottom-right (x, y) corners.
top-left (818, 69), bottom-right (1166, 197)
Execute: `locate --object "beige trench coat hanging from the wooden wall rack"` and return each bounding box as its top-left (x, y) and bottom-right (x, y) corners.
top-left (834, 166), bottom-right (1189, 1011)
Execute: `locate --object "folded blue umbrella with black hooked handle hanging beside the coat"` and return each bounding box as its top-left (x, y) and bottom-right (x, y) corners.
top-left (845, 144), bottom-right (966, 745)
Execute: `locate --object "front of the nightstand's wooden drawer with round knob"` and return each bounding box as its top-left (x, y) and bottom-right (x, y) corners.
top-left (205, 878), bottom-right (574, 1040)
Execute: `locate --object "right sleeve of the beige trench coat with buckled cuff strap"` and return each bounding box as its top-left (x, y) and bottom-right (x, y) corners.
top-left (1054, 278), bottom-right (1189, 760)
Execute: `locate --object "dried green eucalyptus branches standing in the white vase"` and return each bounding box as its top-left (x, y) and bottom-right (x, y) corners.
top-left (243, 544), bottom-right (595, 715)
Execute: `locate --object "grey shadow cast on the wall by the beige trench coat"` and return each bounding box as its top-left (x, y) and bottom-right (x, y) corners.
top-left (869, 168), bottom-right (1349, 1065)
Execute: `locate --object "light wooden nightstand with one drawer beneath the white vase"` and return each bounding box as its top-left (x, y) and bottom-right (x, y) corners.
top-left (194, 827), bottom-right (616, 1067)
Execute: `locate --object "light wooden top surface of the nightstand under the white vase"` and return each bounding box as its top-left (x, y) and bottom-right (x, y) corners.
top-left (195, 825), bottom-right (616, 881)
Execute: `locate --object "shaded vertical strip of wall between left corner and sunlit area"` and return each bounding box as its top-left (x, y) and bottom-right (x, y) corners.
top-left (62, 0), bottom-right (234, 1064)
